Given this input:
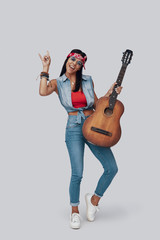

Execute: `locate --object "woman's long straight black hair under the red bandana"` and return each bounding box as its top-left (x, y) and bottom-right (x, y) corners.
top-left (60, 49), bottom-right (87, 92)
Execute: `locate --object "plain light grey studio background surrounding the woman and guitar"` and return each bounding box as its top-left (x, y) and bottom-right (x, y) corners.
top-left (0, 0), bottom-right (160, 240)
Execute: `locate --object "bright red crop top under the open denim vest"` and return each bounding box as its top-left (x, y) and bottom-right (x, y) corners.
top-left (71, 91), bottom-right (87, 108)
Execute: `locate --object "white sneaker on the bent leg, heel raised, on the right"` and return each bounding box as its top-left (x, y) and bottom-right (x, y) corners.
top-left (85, 193), bottom-right (99, 222)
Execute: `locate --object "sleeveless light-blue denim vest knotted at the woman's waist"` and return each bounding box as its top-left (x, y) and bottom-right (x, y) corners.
top-left (56, 74), bottom-right (94, 124)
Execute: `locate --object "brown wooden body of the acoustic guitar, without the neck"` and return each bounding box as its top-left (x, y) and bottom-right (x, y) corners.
top-left (82, 97), bottom-right (124, 147)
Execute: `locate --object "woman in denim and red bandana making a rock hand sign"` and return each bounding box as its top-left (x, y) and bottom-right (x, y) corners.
top-left (39, 49), bottom-right (122, 228)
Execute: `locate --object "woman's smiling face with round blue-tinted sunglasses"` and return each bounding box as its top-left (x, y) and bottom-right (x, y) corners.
top-left (66, 56), bottom-right (83, 74)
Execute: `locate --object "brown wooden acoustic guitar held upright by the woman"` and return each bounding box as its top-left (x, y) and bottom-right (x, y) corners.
top-left (82, 49), bottom-right (133, 147)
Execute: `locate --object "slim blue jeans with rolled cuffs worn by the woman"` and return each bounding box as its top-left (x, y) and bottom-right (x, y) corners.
top-left (65, 115), bottom-right (118, 206)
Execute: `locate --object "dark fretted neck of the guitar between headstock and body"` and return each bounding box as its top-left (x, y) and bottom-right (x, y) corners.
top-left (109, 64), bottom-right (127, 110)
